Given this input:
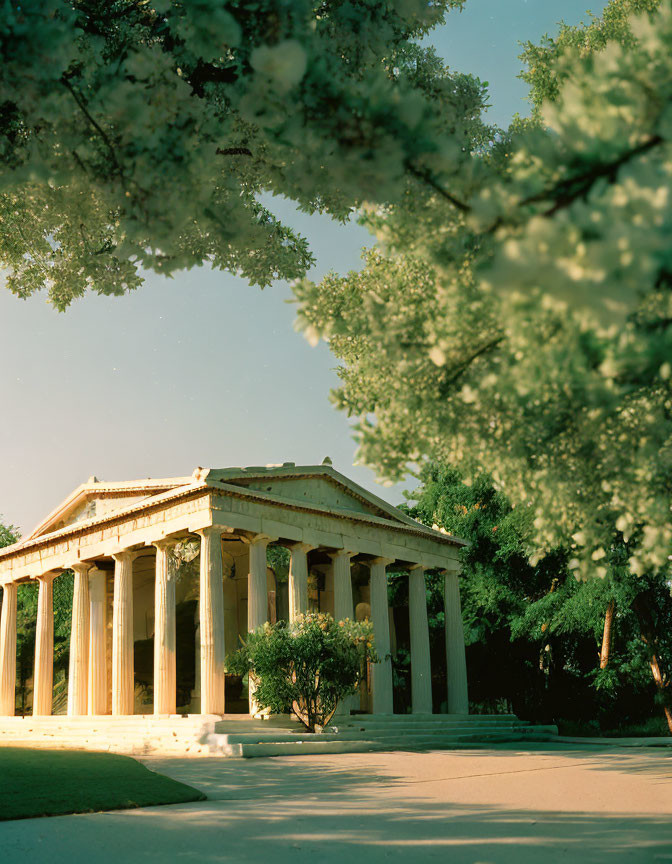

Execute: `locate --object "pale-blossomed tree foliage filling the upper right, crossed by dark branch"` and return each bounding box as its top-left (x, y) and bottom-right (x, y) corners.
top-left (295, 0), bottom-right (672, 578)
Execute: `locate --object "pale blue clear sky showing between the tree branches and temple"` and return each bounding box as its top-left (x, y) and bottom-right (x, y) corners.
top-left (0, 0), bottom-right (605, 531)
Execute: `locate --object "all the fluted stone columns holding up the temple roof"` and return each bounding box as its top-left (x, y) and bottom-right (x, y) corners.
top-left (0, 527), bottom-right (468, 715)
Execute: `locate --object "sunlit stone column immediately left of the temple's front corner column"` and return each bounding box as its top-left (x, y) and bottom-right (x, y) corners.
top-left (154, 540), bottom-right (177, 714)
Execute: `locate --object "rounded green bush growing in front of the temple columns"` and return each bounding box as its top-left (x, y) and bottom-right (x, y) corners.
top-left (227, 613), bottom-right (376, 732)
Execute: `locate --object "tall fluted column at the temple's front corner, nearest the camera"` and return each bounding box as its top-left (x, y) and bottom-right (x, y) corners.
top-left (197, 527), bottom-right (226, 714)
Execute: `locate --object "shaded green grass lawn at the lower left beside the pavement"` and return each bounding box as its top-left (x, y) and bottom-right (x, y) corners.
top-left (0, 747), bottom-right (206, 820)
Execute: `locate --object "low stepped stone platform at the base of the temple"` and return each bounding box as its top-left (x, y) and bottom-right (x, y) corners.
top-left (0, 714), bottom-right (558, 758)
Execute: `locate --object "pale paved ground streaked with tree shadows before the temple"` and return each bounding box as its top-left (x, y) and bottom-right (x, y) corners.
top-left (0, 744), bottom-right (672, 864)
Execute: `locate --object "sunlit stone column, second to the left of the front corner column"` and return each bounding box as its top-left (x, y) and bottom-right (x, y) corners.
top-left (112, 550), bottom-right (135, 714)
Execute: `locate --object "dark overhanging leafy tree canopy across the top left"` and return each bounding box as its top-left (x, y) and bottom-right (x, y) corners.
top-left (0, 0), bottom-right (484, 309)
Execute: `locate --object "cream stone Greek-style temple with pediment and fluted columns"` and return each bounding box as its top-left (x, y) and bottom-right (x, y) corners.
top-left (0, 463), bottom-right (468, 717)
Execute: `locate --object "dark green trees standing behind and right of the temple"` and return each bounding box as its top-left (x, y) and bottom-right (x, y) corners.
top-left (408, 464), bottom-right (672, 734)
